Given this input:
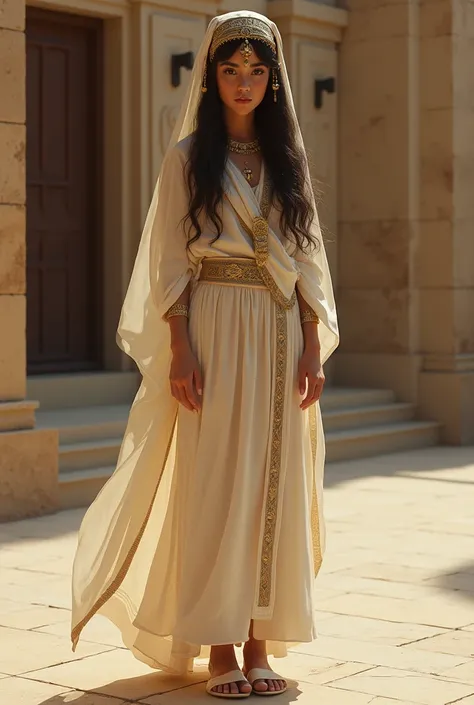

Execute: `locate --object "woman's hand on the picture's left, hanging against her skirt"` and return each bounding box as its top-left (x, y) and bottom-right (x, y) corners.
top-left (170, 343), bottom-right (202, 411)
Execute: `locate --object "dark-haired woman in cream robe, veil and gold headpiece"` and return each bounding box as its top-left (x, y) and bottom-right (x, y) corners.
top-left (72, 11), bottom-right (338, 698)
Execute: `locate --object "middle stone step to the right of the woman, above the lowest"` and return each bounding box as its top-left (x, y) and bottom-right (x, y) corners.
top-left (322, 402), bottom-right (415, 432)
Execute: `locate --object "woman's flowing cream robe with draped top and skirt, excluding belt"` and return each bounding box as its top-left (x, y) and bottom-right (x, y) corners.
top-left (72, 138), bottom-right (337, 672)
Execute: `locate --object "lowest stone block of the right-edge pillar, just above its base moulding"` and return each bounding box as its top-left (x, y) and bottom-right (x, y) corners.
top-left (419, 289), bottom-right (455, 354)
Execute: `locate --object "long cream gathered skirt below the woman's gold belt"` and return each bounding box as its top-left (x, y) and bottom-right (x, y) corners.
top-left (101, 274), bottom-right (315, 672)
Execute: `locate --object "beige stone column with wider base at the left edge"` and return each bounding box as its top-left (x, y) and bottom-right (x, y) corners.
top-left (0, 0), bottom-right (58, 521)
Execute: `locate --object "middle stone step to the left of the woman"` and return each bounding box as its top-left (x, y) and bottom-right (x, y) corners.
top-left (59, 438), bottom-right (122, 473)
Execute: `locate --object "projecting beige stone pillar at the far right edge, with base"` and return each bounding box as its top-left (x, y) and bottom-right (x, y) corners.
top-left (417, 0), bottom-right (474, 444)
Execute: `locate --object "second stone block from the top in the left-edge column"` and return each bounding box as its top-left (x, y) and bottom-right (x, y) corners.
top-left (0, 29), bottom-right (26, 123)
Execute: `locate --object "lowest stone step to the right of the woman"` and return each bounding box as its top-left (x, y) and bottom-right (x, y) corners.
top-left (326, 421), bottom-right (440, 462)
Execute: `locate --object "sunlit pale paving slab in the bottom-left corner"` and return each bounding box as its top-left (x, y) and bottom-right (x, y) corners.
top-left (0, 680), bottom-right (125, 705)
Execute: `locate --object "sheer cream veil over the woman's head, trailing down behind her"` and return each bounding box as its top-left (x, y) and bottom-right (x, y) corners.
top-left (71, 11), bottom-right (338, 666)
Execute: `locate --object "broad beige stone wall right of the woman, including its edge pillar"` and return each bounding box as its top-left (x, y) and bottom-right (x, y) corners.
top-left (336, 0), bottom-right (474, 443)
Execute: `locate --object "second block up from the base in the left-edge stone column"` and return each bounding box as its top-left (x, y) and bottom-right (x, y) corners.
top-left (0, 205), bottom-right (26, 294)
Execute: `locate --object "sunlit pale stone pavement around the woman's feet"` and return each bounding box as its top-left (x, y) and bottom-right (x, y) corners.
top-left (0, 448), bottom-right (474, 705)
